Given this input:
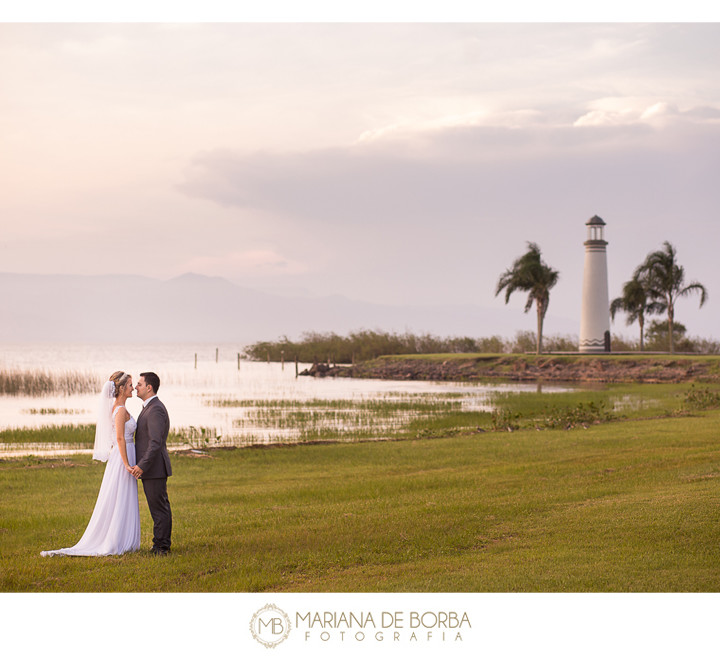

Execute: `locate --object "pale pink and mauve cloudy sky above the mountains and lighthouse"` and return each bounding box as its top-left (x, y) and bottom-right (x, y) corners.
top-left (0, 15), bottom-right (720, 339)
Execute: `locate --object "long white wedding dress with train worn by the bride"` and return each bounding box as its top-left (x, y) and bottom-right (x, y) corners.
top-left (40, 407), bottom-right (140, 557)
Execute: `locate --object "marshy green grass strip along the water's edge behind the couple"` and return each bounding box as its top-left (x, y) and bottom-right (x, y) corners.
top-left (0, 383), bottom-right (720, 446)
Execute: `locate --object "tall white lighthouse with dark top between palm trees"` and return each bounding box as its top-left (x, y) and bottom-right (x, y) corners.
top-left (580, 215), bottom-right (610, 353)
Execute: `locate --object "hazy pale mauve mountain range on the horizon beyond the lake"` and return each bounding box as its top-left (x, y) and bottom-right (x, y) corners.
top-left (0, 273), bottom-right (577, 344)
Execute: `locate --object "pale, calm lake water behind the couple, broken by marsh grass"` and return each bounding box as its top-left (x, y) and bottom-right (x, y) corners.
top-left (0, 340), bottom-right (567, 456)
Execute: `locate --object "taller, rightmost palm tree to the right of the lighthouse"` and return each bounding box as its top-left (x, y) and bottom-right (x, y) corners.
top-left (634, 241), bottom-right (708, 352)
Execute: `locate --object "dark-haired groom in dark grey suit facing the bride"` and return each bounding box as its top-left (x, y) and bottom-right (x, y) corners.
top-left (132, 372), bottom-right (172, 555)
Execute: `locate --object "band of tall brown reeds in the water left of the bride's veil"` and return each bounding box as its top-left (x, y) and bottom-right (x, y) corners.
top-left (0, 370), bottom-right (102, 397)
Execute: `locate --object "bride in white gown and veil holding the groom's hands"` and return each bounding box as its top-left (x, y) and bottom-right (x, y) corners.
top-left (40, 371), bottom-right (140, 557)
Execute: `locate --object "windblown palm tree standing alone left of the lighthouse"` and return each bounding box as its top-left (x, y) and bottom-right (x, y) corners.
top-left (495, 242), bottom-right (560, 354)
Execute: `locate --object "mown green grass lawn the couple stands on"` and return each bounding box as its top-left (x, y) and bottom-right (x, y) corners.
top-left (0, 411), bottom-right (720, 592)
